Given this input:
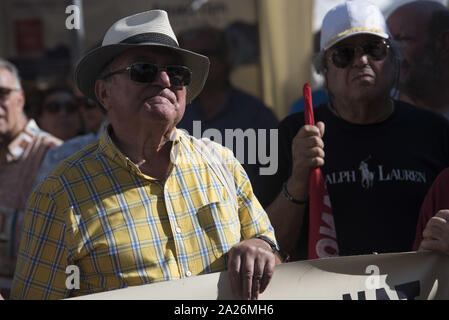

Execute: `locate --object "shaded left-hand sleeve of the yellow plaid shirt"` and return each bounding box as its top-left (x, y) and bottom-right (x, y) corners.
top-left (11, 185), bottom-right (70, 300)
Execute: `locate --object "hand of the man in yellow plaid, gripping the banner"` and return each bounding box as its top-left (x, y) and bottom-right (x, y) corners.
top-left (228, 238), bottom-right (275, 300)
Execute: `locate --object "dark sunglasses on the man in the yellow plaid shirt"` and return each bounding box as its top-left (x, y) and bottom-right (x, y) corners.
top-left (102, 62), bottom-right (192, 87)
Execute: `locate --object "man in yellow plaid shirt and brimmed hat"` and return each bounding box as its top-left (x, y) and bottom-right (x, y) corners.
top-left (12, 10), bottom-right (277, 299)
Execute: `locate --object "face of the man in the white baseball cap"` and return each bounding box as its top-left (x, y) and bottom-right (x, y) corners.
top-left (324, 35), bottom-right (394, 100)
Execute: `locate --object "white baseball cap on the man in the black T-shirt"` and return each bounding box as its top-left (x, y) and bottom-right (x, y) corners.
top-left (320, 0), bottom-right (390, 50)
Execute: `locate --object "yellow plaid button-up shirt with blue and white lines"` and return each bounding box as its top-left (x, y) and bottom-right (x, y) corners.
top-left (11, 130), bottom-right (275, 299)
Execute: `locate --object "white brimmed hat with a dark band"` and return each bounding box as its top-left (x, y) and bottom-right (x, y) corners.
top-left (75, 10), bottom-right (209, 103)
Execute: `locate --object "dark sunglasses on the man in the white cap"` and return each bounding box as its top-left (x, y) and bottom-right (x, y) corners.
top-left (331, 40), bottom-right (390, 68)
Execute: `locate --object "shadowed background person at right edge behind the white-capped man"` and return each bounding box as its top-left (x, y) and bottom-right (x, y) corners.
top-left (387, 1), bottom-right (449, 117)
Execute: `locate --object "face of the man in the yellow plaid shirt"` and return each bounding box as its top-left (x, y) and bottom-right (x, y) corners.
top-left (97, 47), bottom-right (186, 130)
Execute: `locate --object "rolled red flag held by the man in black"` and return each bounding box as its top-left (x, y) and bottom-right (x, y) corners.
top-left (303, 83), bottom-right (338, 259)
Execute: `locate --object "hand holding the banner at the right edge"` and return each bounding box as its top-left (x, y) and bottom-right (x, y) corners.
top-left (418, 210), bottom-right (449, 255)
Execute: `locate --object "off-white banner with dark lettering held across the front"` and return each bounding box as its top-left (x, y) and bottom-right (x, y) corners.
top-left (68, 252), bottom-right (449, 300)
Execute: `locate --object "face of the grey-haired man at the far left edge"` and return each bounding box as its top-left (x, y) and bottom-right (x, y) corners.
top-left (0, 68), bottom-right (25, 136)
